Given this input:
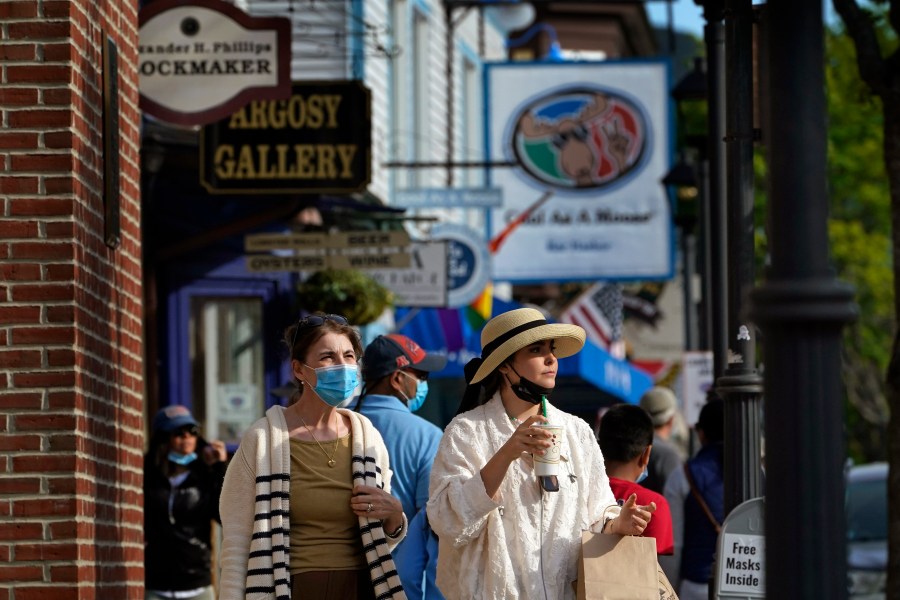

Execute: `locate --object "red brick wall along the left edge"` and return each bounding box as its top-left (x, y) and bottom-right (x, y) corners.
top-left (0, 0), bottom-right (143, 600)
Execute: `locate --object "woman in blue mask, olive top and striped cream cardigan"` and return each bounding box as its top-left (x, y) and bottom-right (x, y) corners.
top-left (219, 313), bottom-right (408, 600)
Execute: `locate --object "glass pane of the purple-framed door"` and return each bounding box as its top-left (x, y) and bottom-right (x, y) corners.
top-left (189, 297), bottom-right (265, 443)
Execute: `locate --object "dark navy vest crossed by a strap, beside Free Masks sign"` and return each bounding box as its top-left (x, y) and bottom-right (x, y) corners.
top-left (681, 442), bottom-right (725, 583)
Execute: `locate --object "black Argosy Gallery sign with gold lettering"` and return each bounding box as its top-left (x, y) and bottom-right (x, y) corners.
top-left (200, 81), bottom-right (372, 194)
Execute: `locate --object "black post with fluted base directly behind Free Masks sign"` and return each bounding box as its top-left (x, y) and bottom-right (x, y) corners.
top-left (715, 0), bottom-right (762, 514)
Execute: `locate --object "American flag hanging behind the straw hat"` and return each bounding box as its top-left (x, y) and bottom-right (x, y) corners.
top-left (559, 282), bottom-right (625, 358)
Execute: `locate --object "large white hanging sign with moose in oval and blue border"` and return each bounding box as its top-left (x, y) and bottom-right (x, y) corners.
top-left (485, 59), bottom-right (674, 282)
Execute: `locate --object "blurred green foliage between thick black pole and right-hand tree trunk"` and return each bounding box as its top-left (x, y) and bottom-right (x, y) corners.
top-left (825, 19), bottom-right (896, 461)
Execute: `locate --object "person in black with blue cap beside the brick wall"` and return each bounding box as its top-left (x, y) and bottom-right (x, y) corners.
top-left (144, 405), bottom-right (228, 600)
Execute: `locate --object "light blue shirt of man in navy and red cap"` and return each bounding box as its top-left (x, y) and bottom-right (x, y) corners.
top-left (357, 394), bottom-right (442, 521)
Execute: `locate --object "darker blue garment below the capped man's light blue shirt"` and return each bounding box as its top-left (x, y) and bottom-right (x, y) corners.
top-left (391, 509), bottom-right (444, 600)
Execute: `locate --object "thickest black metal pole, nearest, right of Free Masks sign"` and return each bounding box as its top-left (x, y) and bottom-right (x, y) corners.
top-left (751, 0), bottom-right (856, 600)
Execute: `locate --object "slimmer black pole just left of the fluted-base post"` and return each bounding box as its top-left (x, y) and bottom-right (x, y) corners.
top-left (703, 0), bottom-right (728, 377)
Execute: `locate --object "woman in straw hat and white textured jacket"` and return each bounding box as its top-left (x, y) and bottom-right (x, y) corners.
top-left (427, 308), bottom-right (656, 600)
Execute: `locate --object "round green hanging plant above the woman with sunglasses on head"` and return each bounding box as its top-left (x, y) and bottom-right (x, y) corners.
top-left (297, 270), bottom-right (394, 325)
